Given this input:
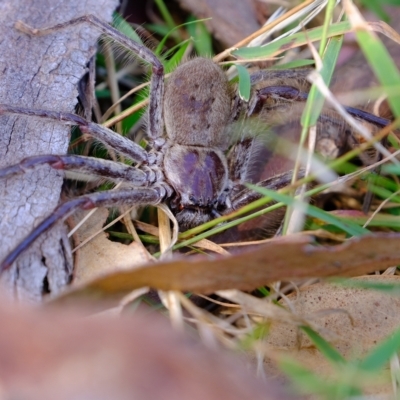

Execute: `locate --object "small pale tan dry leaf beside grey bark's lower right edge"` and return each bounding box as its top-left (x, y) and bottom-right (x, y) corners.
top-left (73, 208), bottom-right (151, 285)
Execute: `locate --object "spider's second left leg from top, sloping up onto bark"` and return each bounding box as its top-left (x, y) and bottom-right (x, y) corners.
top-left (0, 104), bottom-right (149, 163)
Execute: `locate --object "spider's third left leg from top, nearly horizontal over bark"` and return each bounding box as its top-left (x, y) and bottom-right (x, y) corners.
top-left (0, 155), bottom-right (155, 186)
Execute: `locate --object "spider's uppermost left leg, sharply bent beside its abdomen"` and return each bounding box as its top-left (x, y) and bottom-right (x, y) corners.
top-left (15, 14), bottom-right (164, 144)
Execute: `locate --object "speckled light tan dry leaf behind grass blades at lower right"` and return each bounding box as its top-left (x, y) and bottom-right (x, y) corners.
top-left (264, 275), bottom-right (400, 391)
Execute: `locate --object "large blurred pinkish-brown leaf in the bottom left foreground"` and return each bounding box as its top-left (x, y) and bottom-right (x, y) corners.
top-left (0, 301), bottom-right (289, 400)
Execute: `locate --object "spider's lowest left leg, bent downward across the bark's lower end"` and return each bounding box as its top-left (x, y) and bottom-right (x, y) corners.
top-left (0, 187), bottom-right (165, 273)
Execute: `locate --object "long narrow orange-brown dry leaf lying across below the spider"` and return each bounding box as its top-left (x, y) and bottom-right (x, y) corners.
top-left (54, 233), bottom-right (400, 301)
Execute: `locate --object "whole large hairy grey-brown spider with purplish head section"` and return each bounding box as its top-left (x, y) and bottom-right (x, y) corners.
top-left (0, 15), bottom-right (388, 271)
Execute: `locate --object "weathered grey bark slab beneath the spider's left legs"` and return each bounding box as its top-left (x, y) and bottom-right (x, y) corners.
top-left (0, 0), bottom-right (118, 302)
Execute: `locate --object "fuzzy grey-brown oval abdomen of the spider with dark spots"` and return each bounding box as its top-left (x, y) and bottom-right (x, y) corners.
top-left (164, 58), bottom-right (231, 150)
